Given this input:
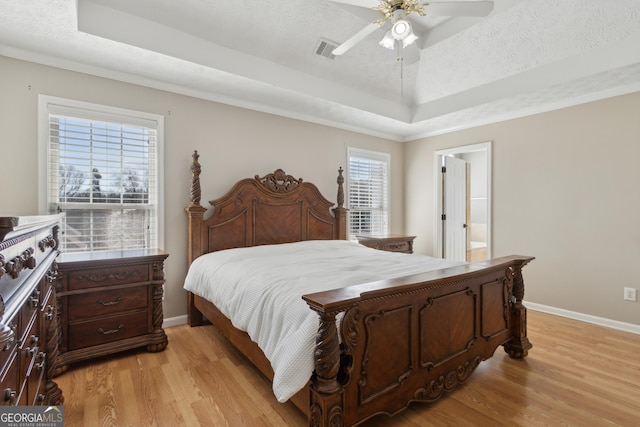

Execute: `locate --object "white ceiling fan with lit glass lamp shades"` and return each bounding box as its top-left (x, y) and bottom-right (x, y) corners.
top-left (329, 0), bottom-right (493, 55)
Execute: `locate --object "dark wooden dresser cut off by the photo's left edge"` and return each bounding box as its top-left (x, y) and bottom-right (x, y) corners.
top-left (0, 215), bottom-right (64, 406)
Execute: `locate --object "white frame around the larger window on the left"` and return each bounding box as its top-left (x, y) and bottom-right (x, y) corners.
top-left (38, 94), bottom-right (164, 253)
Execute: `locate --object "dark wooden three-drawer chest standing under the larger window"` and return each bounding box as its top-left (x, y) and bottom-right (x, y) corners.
top-left (54, 250), bottom-right (169, 375)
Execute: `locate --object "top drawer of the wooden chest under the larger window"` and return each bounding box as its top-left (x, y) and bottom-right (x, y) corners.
top-left (67, 264), bottom-right (149, 291)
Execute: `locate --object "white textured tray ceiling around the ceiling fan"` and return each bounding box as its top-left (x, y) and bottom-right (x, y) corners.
top-left (0, 0), bottom-right (640, 141)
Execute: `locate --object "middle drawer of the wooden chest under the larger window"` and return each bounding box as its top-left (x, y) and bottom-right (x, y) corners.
top-left (67, 286), bottom-right (149, 322)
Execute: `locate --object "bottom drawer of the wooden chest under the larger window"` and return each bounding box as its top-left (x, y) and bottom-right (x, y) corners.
top-left (69, 310), bottom-right (149, 350)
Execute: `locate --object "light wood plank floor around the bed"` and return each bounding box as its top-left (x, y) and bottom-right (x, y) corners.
top-left (56, 310), bottom-right (640, 427)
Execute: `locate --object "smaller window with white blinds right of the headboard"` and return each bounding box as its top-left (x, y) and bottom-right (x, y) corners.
top-left (347, 148), bottom-right (389, 238)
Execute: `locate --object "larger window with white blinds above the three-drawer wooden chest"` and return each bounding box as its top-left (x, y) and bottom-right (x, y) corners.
top-left (39, 96), bottom-right (163, 252)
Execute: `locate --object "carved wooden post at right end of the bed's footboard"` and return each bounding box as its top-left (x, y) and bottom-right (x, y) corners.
top-left (504, 259), bottom-right (533, 359)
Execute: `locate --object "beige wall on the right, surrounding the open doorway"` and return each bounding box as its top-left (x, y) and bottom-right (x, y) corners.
top-left (405, 93), bottom-right (640, 325)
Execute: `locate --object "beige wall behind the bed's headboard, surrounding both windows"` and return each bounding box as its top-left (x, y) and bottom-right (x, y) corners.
top-left (0, 56), bottom-right (404, 318)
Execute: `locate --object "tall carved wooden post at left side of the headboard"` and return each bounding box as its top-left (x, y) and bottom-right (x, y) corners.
top-left (184, 150), bottom-right (207, 326)
